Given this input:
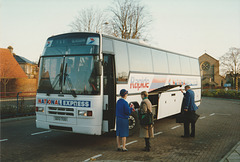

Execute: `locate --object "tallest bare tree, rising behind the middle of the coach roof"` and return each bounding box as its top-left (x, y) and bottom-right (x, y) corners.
top-left (109, 0), bottom-right (151, 39)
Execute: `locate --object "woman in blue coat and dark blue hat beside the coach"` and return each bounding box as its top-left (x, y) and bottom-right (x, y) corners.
top-left (116, 89), bottom-right (135, 151)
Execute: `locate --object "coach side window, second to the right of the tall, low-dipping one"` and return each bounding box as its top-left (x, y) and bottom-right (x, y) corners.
top-left (152, 50), bottom-right (168, 73)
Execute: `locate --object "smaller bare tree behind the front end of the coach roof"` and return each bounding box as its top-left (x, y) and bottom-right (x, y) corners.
top-left (70, 8), bottom-right (106, 32)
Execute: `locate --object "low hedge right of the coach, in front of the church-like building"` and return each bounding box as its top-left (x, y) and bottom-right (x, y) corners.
top-left (202, 89), bottom-right (240, 99)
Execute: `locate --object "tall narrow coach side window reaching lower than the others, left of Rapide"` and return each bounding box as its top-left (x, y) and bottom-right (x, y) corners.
top-left (114, 40), bottom-right (129, 83)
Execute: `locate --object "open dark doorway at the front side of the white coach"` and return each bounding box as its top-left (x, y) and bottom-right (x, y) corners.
top-left (103, 54), bottom-right (116, 132)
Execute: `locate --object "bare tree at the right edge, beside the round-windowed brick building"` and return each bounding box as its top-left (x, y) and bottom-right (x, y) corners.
top-left (219, 47), bottom-right (240, 89)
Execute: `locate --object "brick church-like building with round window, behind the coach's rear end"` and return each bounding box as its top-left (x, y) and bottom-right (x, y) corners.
top-left (199, 53), bottom-right (226, 87)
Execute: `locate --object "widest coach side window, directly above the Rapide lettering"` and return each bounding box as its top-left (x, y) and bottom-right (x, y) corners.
top-left (128, 44), bottom-right (153, 73)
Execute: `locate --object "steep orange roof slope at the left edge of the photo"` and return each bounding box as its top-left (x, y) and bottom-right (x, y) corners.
top-left (0, 48), bottom-right (27, 79)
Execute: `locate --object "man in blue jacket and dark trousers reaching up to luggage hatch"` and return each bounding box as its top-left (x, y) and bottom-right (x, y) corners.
top-left (181, 85), bottom-right (198, 137)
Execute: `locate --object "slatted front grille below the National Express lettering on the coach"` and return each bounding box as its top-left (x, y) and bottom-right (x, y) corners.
top-left (48, 107), bottom-right (74, 116)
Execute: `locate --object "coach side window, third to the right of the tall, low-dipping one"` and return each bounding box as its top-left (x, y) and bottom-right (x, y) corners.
top-left (168, 53), bottom-right (181, 74)
